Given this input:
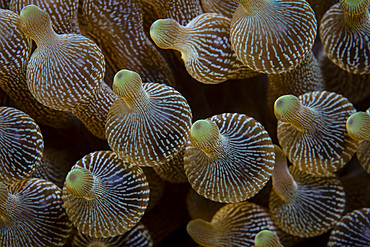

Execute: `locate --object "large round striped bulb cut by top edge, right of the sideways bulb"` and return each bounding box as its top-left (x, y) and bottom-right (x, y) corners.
top-left (230, 0), bottom-right (317, 74)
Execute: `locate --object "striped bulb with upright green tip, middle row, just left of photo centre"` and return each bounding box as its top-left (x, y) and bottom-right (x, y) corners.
top-left (106, 70), bottom-right (192, 166)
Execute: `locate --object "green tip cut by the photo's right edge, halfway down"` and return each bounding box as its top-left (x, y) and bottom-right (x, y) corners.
top-left (346, 112), bottom-right (370, 141)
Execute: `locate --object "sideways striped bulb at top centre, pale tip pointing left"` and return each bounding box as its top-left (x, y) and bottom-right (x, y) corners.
top-left (150, 13), bottom-right (258, 84)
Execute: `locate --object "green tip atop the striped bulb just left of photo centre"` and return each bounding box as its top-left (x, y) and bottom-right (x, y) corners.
top-left (112, 69), bottom-right (142, 98)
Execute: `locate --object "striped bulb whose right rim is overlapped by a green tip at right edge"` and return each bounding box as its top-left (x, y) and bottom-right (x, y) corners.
top-left (274, 91), bottom-right (358, 175)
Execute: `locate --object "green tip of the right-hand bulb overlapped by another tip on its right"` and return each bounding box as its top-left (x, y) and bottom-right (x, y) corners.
top-left (274, 95), bottom-right (301, 120)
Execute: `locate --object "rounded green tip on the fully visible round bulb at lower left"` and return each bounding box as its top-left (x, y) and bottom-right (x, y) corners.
top-left (65, 168), bottom-right (94, 198)
